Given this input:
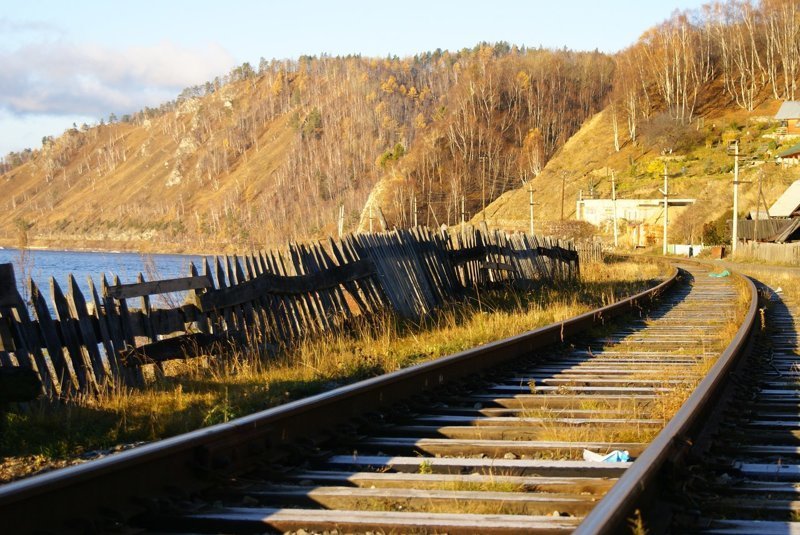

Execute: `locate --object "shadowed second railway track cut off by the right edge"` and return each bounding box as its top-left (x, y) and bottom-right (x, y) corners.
top-left (669, 278), bottom-right (800, 534)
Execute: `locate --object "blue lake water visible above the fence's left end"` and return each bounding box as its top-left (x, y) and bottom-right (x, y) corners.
top-left (0, 249), bottom-right (209, 302)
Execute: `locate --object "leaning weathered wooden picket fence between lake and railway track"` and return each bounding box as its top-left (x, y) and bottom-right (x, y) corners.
top-left (0, 227), bottom-right (579, 399)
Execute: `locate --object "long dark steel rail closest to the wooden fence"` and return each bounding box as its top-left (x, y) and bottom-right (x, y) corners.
top-left (0, 269), bottom-right (679, 533)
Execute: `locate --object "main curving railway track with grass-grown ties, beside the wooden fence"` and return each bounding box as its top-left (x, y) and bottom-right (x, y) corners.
top-left (0, 266), bottom-right (753, 533)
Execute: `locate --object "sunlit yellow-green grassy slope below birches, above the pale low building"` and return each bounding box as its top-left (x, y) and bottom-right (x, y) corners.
top-left (482, 101), bottom-right (800, 241)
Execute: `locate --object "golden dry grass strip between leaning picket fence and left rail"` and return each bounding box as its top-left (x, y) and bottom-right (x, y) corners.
top-left (0, 262), bottom-right (664, 480)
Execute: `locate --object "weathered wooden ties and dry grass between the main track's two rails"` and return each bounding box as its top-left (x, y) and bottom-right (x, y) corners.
top-left (135, 266), bottom-right (744, 533)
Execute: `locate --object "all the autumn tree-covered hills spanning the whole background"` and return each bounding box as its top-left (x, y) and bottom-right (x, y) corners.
top-left (0, 0), bottom-right (800, 251)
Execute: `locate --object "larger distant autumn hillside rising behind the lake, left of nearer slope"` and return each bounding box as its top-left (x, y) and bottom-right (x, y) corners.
top-left (0, 44), bottom-right (612, 250)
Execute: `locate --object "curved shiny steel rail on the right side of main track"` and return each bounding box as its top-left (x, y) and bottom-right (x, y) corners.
top-left (574, 266), bottom-right (758, 535)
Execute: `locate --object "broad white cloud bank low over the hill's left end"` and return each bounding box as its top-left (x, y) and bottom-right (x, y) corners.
top-left (0, 39), bottom-right (235, 117)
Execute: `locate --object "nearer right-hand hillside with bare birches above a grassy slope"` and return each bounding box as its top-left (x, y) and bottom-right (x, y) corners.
top-left (478, 0), bottom-right (800, 243)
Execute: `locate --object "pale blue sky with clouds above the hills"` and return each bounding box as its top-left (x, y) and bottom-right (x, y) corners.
top-left (0, 0), bottom-right (704, 157)
